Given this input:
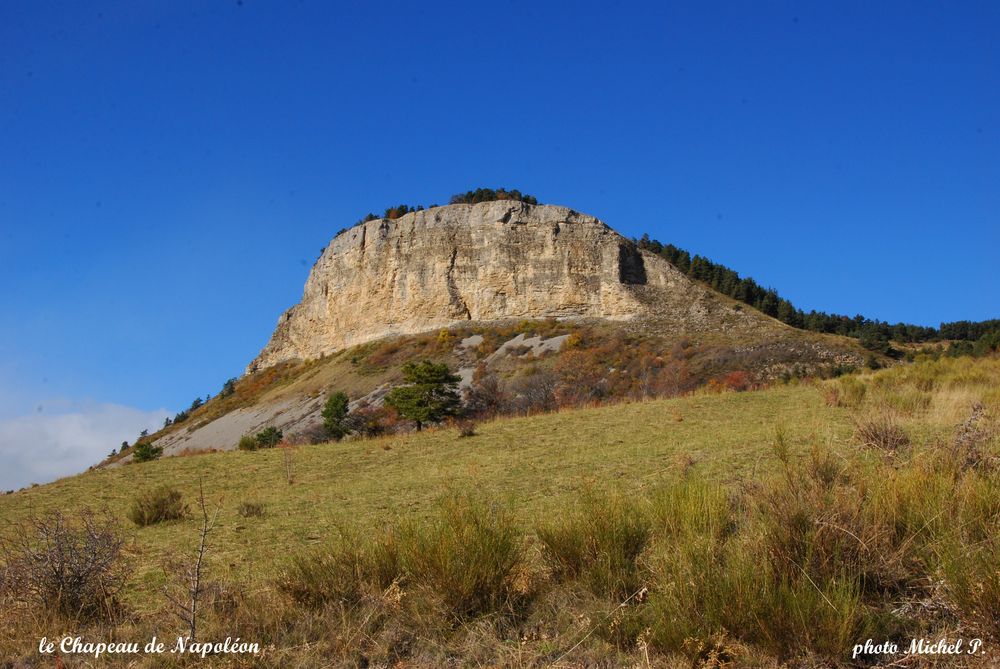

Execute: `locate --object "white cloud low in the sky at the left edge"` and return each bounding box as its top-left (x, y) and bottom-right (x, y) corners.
top-left (0, 404), bottom-right (169, 490)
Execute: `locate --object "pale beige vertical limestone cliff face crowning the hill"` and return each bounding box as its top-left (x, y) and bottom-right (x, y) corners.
top-left (248, 201), bottom-right (777, 371)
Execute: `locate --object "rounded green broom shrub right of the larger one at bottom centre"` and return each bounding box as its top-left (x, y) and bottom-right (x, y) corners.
top-left (537, 493), bottom-right (651, 599)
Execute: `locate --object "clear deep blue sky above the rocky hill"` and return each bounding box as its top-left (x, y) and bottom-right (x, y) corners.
top-left (0, 0), bottom-right (1000, 487)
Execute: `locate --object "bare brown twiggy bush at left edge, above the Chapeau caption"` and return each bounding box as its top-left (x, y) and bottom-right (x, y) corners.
top-left (0, 511), bottom-right (126, 619)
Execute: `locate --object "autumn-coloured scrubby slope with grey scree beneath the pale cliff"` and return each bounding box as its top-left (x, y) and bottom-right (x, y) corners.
top-left (123, 318), bottom-right (863, 456)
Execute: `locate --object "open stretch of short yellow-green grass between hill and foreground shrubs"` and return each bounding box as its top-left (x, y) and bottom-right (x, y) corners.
top-left (0, 385), bottom-right (851, 610)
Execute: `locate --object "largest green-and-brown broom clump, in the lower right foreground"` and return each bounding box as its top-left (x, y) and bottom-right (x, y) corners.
top-left (648, 456), bottom-right (902, 660)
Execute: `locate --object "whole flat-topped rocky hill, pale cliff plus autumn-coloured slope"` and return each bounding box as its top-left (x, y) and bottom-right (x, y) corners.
top-left (121, 200), bottom-right (868, 461)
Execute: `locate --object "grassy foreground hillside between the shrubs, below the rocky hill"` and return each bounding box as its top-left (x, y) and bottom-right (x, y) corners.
top-left (0, 359), bottom-right (1000, 667)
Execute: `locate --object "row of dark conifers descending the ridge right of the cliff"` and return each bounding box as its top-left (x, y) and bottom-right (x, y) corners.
top-left (636, 234), bottom-right (1000, 353)
